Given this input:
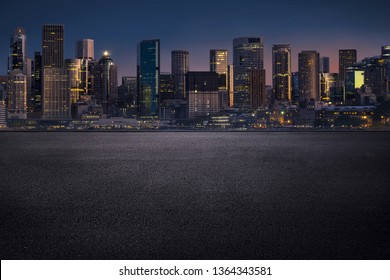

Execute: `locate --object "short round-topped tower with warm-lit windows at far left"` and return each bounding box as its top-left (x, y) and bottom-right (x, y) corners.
top-left (8, 69), bottom-right (27, 119)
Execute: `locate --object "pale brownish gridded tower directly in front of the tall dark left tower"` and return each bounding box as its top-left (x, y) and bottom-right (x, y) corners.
top-left (42, 67), bottom-right (71, 120)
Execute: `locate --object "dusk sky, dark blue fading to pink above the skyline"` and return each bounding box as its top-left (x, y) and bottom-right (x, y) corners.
top-left (0, 0), bottom-right (390, 84)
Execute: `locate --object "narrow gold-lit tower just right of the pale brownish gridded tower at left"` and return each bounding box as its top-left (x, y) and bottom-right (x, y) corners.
top-left (65, 59), bottom-right (81, 104)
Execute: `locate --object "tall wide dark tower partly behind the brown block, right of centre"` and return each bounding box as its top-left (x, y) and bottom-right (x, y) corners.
top-left (233, 37), bottom-right (264, 110)
